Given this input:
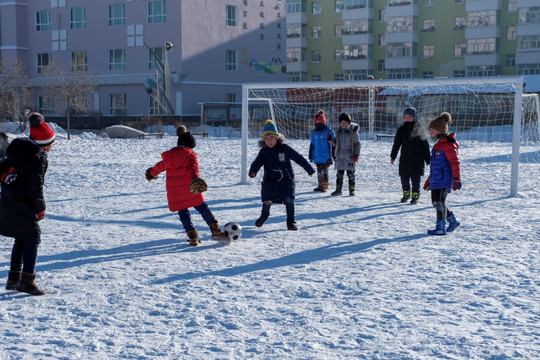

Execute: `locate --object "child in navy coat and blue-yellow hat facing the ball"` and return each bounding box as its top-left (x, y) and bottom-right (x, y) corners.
top-left (248, 120), bottom-right (315, 230)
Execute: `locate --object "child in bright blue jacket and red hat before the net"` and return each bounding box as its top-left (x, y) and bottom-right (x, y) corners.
top-left (309, 110), bottom-right (336, 192)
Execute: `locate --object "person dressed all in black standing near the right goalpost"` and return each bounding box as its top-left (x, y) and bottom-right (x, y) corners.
top-left (390, 107), bottom-right (431, 204)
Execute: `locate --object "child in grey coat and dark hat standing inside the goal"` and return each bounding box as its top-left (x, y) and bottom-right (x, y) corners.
top-left (327, 113), bottom-right (361, 196)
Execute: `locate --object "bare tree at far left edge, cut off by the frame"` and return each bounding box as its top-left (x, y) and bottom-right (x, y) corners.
top-left (0, 59), bottom-right (32, 121)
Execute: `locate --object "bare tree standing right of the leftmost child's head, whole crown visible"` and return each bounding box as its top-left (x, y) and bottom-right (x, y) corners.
top-left (38, 63), bottom-right (96, 140)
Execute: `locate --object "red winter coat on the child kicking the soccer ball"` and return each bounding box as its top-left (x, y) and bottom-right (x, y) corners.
top-left (150, 146), bottom-right (204, 211)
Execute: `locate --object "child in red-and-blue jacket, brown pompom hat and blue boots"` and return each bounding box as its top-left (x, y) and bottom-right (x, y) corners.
top-left (424, 112), bottom-right (461, 235)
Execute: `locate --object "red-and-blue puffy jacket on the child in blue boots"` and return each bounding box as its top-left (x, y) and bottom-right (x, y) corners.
top-left (429, 134), bottom-right (461, 192)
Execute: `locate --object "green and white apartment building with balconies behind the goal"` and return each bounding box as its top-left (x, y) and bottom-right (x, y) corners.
top-left (286, 0), bottom-right (540, 86)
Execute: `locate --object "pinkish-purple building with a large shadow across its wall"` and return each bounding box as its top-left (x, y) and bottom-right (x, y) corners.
top-left (0, 0), bottom-right (286, 124)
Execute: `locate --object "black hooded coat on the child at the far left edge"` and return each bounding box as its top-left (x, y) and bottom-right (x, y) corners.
top-left (0, 138), bottom-right (48, 238)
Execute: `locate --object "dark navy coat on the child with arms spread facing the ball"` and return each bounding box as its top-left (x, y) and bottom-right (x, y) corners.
top-left (249, 138), bottom-right (315, 202)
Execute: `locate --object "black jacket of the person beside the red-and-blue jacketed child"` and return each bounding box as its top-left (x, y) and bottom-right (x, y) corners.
top-left (390, 121), bottom-right (430, 176)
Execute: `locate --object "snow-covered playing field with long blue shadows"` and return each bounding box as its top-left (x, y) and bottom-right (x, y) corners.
top-left (0, 127), bottom-right (540, 360)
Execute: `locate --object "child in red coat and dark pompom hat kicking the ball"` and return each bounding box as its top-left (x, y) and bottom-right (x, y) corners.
top-left (145, 125), bottom-right (224, 246)
